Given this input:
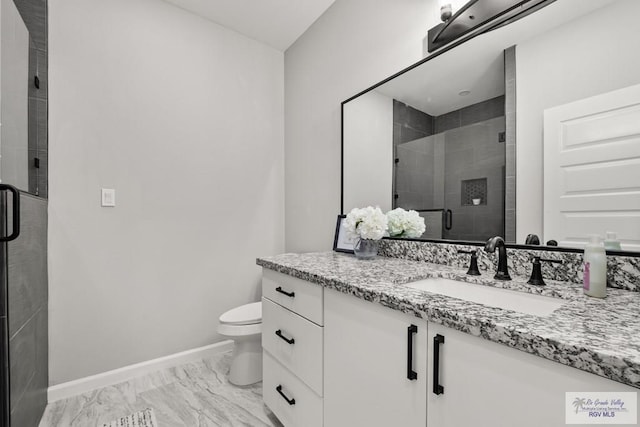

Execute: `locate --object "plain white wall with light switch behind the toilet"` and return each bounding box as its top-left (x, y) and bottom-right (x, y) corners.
top-left (49, 0), bottom-right (284, 385)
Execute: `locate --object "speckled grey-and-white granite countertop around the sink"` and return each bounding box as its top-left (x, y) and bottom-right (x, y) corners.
top-left (257, 252), bottom-right (640, 388)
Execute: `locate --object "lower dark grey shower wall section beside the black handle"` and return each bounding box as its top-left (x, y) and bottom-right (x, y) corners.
top-left (8, 193), bottom-right (49, 427)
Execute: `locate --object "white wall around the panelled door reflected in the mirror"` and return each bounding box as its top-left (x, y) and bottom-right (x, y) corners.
top-left (516, 0), bottom-right (640, 243)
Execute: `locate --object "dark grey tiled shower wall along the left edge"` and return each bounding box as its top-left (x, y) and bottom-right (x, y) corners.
top-left (8, 0), bottom-right (49, 427)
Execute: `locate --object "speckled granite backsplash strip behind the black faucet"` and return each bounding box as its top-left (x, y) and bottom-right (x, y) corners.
top-left (378, 239), bottom-right (640, 292)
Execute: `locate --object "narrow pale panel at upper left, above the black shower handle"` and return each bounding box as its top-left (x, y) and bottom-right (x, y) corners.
top-left (0, 0), bottom-right (29, 190)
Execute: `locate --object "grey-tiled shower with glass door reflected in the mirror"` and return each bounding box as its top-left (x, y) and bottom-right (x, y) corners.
top-left (393, 97), bottom-right (506, 241)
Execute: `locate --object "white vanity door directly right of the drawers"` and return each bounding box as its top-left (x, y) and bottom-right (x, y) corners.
top-left (324, 289), bottom-right (427, 427)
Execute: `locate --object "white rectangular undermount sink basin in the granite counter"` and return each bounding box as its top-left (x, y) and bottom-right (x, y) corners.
top-left (406, 277), bottom-right (565, 316)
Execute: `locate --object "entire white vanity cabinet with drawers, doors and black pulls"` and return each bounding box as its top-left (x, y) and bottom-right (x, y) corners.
top-left (262, 269), bottom-right (640, 427)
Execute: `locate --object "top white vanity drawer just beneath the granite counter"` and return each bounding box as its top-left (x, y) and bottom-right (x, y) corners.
top-left (262, 268), bottom-right (323, 325)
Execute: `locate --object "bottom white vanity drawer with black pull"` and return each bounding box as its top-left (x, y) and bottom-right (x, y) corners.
top-left (262, 352), bottom-right (322, 427)
